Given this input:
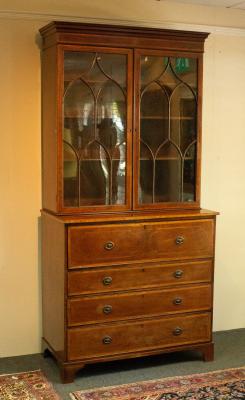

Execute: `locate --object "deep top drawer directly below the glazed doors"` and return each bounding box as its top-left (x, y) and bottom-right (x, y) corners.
top-left (68, 219), bottom-right (214, 268)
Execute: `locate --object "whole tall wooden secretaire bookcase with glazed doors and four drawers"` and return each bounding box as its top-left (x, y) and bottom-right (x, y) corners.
top-left (40, 22), bottom-right (217, 382)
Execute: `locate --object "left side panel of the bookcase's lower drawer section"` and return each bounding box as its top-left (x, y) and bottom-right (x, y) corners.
top-left (42, 215), bottom-right (65, 359)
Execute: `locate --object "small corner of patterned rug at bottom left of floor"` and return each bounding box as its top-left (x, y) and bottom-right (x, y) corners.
top-left (0, 371), bottom-right (61, 400)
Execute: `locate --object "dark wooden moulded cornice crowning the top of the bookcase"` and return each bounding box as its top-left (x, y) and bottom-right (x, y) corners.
top-left (40, 21), bottom-right (209, 52)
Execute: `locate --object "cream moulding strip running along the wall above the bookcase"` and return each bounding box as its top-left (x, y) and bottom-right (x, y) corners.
top-left (0, 10), bottom-right (245, 37)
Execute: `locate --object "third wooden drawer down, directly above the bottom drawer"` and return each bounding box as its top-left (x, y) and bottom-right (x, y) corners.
top-left (67, 285), bottom-right (212, 326)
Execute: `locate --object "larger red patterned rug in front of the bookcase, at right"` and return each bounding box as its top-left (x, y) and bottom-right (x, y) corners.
top-left (70, 367), bottom-right (245, 400)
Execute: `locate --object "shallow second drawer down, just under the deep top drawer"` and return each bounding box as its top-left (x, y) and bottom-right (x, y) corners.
top-left (68, 260), bottom-right (213, 296)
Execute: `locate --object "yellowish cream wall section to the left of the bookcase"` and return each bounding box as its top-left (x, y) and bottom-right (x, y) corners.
top-left (0, 20), bottom-right (41, 356)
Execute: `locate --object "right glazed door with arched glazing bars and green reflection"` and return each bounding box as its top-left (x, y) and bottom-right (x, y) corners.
top-left (134, 50), bottom-right (202, 209)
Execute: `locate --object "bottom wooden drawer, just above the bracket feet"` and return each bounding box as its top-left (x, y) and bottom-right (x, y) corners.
top-left (67, 313), bottom-right (211, 361)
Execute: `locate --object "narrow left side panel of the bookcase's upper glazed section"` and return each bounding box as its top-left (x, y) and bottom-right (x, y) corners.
top-left (42, 47), bottom-right (57, 211)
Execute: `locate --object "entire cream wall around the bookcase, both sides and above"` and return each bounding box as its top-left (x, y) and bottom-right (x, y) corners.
top-left (0, 0), bottom-right (245, 356)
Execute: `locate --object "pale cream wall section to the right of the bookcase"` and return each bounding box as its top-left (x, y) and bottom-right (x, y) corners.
top-left (202, 35), bottom-right (245, 330)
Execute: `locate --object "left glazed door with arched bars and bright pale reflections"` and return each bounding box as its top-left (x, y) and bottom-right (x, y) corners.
top-left (59, 46), bottom-right (132, 212)
